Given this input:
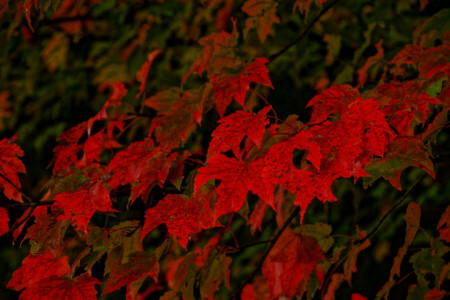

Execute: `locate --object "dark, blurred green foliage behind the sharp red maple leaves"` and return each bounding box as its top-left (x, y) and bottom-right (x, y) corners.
top-left (0, 0), bottom-right (450, 299)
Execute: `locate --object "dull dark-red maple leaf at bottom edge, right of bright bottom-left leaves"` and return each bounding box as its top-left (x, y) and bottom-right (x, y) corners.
top-left (103, 252), bottom-right (159, 295)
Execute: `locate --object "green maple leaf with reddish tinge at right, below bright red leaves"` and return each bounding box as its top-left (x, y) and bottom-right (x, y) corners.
top-left (364, 136), bottom-right (435, 191)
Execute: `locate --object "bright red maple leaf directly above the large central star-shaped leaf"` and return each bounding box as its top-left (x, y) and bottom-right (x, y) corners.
top-left (207, 106), bottom-right (272, 158)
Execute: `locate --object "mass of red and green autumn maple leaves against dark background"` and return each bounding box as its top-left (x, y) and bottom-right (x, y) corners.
top-left (0, 0), bottom-right (450, 300)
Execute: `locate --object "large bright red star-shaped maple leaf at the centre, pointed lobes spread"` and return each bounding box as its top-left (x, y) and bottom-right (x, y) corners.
top-left (194, 154), bottom-right (273, 220)
